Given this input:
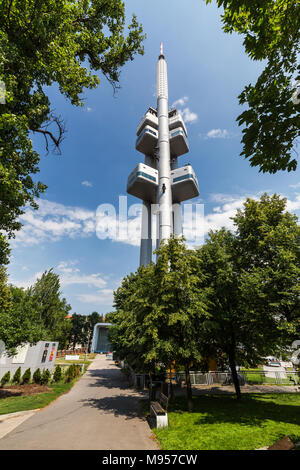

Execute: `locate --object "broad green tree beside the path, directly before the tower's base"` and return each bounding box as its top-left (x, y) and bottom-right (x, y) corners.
top-left (110, 238), bottom-right (208, 410)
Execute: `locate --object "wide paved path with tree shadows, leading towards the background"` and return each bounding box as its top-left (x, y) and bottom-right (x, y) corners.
top-left (0, 355), bottom-right (158, 450)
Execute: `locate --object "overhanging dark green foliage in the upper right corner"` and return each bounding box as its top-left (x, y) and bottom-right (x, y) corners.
top-left (206, 0), bottom-right (300, 173)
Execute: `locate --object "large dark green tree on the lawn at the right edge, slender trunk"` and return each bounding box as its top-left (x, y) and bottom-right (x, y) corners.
top-left (197, 194), bottom-right (300, 399)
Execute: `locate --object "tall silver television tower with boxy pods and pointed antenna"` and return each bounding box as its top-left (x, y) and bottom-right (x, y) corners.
top-left (127, 44), bottom-right (199, 265)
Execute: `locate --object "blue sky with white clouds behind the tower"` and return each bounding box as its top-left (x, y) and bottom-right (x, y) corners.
top-left (8, 0), bottom-right (300, 314)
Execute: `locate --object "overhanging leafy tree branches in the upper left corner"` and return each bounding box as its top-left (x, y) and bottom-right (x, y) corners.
top-left (0, 0), bottom-right (144, 252)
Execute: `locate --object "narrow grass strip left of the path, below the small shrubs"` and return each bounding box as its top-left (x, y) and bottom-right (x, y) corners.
top-left (0, 381), bottom-right (75, 415)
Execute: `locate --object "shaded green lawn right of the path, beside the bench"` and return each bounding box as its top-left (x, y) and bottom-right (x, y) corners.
top-left (153, 393), bottom-right (300, 450)
